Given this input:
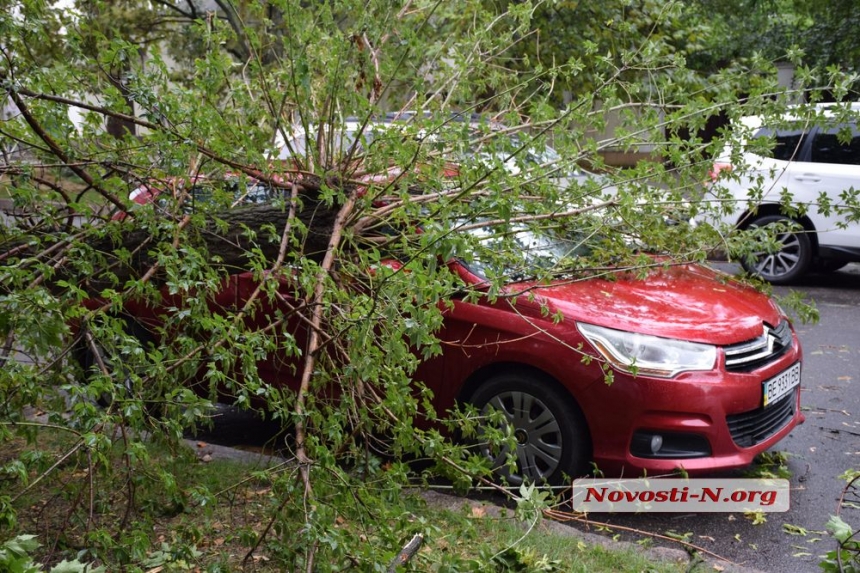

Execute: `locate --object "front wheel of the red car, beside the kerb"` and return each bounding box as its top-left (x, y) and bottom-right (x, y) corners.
top-left (470, 372), bottom-right (591, 486)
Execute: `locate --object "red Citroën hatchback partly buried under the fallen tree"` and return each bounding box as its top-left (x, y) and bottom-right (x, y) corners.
top-left (77, 190), bottom-right (804, 484)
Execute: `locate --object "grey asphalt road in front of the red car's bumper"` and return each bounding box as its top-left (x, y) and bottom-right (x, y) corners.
top-left (576, 264), bottom-right (860, 573)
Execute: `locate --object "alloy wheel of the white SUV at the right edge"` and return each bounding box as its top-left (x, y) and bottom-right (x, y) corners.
top-left (741, 215), bottom-right (812, 285)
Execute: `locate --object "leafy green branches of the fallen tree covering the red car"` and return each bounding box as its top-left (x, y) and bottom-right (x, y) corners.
top-left (0, 0), bottom-right (850, 571)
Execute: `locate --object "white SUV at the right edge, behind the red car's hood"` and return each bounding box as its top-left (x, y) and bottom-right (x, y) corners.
top-left (709, 104), bottom-right (860, 284)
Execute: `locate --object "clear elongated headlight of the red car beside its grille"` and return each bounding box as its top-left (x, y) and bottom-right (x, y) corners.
top-left (577, 322), bottom-right (717, 378)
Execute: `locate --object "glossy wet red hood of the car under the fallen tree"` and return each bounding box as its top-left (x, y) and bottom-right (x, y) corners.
top-left (509, 265), bottom-right (781, 345)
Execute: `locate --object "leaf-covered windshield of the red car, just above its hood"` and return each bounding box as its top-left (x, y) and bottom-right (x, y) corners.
top-left (462, 221), bottom-right (590, 281)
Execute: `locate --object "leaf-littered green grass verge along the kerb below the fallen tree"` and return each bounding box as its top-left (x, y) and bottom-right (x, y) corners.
top-left (0, 428), bottom-right (686, 573)
